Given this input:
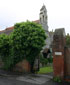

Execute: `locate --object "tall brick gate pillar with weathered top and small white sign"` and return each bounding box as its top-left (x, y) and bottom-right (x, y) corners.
top-left (52, 28), bottom-right (65, 78)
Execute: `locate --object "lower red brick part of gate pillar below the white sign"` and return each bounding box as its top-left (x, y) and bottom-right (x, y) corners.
top-left (53, 56), bottom-right (64, 78)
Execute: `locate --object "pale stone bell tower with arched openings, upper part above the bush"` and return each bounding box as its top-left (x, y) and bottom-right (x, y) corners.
top-left (39, 5), bottom-right (48, 32)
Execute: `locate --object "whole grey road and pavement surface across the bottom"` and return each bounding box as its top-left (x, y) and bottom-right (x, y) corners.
top-left (0, 70), bottom-right (70, 85)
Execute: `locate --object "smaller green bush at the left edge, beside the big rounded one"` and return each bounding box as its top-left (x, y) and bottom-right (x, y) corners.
top-left (0, 34), bottom-right (11, 69)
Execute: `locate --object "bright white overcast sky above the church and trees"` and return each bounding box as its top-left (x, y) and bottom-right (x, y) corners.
top-left (0, 0), bottom-right (70, 34)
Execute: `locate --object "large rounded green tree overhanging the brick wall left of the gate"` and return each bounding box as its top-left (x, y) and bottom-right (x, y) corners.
top-left (10, 21), bottom-right (46, 71)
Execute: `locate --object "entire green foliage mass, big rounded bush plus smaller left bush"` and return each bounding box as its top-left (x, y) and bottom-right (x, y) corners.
top-left (0, 21), bottom-right (46, 69)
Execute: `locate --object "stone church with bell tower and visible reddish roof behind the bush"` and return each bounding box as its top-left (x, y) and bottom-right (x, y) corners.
top-left (0, 5), bottom-right (53, 53)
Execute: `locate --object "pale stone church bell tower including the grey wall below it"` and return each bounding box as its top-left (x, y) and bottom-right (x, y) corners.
top-left (39, 5), bottom-right (51, 49)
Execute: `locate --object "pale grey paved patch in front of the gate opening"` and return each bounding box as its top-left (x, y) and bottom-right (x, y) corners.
top-left (16, 74), bottom-right (53, 85)
